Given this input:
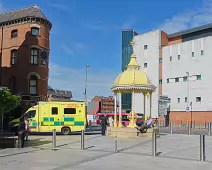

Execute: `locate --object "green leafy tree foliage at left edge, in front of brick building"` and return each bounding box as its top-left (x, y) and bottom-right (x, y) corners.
top-left (0, 88), bottom-right (21, 113)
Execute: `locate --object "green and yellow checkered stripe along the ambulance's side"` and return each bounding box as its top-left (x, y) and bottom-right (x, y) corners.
top-left (40, 117), bottom-right (85, 126)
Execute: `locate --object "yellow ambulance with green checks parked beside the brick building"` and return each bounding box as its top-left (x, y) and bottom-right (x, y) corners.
top-left (10, 102), bottom-right (87, 135)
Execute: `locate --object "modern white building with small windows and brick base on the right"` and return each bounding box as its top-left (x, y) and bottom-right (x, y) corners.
top-left (122, 24), bottom-right (212, 123)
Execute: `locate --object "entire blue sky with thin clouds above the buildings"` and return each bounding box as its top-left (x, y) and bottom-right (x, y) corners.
top-left (0, 0), bottom-right (212, 99)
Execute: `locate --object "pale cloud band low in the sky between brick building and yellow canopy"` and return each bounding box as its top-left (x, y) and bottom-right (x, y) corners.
top-left (49, 63), bottom-right (118, 100)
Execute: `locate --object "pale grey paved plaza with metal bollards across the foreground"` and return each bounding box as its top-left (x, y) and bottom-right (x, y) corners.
top-left (0, 134), bottom-right (212, 170)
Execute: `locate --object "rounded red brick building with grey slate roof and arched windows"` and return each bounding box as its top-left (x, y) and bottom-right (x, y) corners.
top-left (0, 6), bottom-right (52, 105)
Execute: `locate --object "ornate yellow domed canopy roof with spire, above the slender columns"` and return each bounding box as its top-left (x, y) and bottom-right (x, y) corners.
top-left (111, 42), bottom-right (156, 92)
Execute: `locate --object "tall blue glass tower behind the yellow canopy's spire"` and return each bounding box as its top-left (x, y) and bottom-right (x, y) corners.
top-left (122, 30), bottom-right (138, 111)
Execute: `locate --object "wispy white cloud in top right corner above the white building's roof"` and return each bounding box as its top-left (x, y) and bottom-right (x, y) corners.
top-left (160, 0), bottom-right (212, 33)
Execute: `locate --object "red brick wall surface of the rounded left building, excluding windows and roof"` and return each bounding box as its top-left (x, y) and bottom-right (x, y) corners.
top-left (0, 22), bottom-right (50, 96)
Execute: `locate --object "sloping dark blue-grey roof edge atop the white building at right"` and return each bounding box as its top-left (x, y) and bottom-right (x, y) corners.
top-left (168, 23), bottom-right (212, 38)
